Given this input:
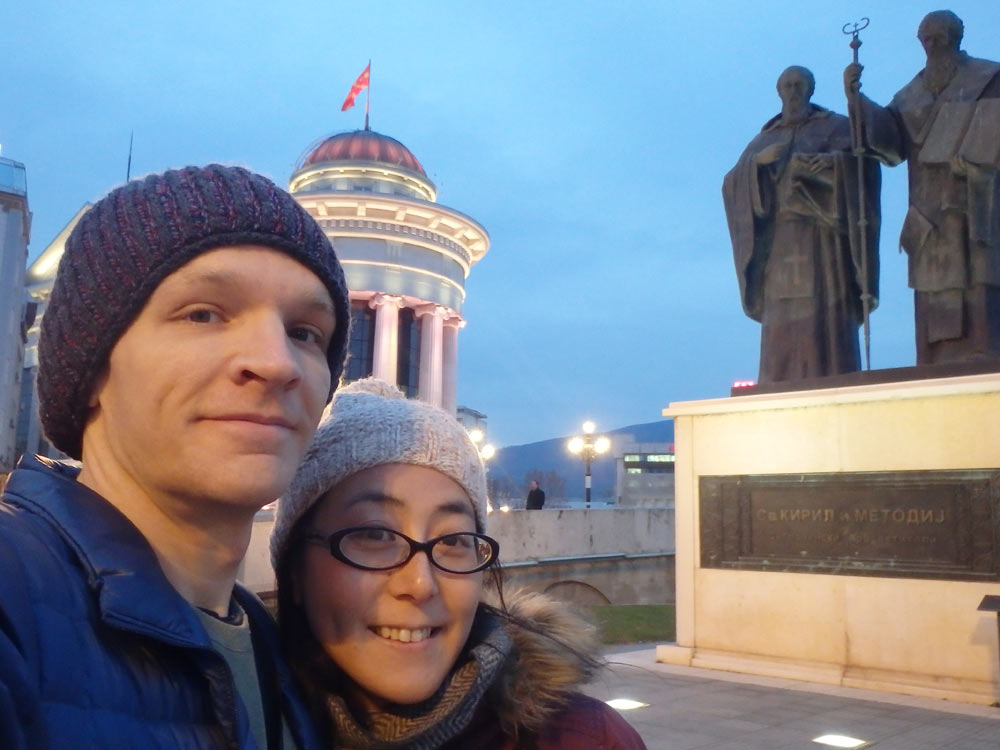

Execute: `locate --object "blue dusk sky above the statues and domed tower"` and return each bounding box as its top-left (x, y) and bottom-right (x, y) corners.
top-left (0, 0), bottom-right (1000, 446)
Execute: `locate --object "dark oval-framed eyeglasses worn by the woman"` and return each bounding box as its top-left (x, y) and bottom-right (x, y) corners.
top-left (304, 526), bottom-right (500, 573)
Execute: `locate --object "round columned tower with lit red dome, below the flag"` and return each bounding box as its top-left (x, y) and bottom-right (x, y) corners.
top-left (288, 129), bottom-right (490, 414)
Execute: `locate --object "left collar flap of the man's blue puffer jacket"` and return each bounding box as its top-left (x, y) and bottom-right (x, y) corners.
top-left (4, 456), bottom-right (211, 648)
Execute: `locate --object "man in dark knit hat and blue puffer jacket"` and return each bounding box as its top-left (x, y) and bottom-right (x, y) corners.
top-left (0, 165), bottom-right (349, 750)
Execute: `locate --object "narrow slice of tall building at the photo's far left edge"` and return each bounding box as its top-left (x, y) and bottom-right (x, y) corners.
top-left (0, 159), bottom-right (31, 474)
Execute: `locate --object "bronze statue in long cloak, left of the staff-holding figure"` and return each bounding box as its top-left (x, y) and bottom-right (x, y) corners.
top-left (722, 65), bottom-right (880, 383)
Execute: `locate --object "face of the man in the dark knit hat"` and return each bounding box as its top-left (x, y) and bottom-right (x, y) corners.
top-left (83, 245), bottom-right (336, 509)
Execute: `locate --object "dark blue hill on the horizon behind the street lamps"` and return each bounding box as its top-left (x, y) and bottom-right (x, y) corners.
top-left (489, 419), bottom-right (674, 502)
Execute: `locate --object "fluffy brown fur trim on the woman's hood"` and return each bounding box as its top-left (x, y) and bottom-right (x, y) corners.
top-left (491, 590), bottom-right (604, 737)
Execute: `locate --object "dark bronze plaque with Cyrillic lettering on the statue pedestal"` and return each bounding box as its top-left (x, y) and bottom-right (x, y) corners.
top-left (699, 470), bottom-right (1000, 581)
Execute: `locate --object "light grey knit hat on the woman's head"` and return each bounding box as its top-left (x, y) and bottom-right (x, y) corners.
top-left (271, 378), bottom-right (486, 569)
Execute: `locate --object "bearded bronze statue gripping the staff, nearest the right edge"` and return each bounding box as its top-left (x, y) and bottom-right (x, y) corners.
top-left (844, 10), bottom-right (1000, 365)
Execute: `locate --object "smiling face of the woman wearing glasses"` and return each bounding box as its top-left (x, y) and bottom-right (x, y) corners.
top-left (297, 464), bottom-right (483, 707)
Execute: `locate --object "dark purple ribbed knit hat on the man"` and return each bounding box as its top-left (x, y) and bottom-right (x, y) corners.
top-left (38, 164), bottom-right (350, 458)
